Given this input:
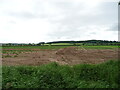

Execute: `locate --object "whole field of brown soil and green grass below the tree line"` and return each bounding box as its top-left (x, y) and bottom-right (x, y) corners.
top-left (2, 46), bottom-right (120, 88)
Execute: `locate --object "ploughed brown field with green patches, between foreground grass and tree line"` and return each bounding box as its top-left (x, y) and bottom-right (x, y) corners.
top-left (2, 46), bottom-right (118, 66)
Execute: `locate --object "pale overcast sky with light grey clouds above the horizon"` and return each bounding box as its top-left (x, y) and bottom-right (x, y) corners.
top-left (0, 0), bottom-right (119, 43)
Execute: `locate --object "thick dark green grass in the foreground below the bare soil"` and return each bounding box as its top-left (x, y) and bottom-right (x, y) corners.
top-left (2, 60), bottom-right (120, 89)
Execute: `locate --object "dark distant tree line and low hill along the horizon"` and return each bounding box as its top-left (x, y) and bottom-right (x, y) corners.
top-left (2, 40), bottom-right (120, 46)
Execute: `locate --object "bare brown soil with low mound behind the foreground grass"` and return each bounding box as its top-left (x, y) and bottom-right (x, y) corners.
top-left (2, 47), bottom-right (118, 65)
